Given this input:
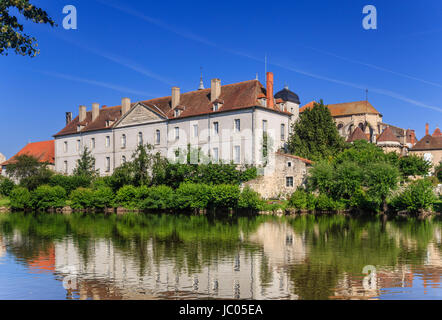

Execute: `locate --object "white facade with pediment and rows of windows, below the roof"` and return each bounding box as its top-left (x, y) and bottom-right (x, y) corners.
top-left (55, 102), bottom-right (299, 175)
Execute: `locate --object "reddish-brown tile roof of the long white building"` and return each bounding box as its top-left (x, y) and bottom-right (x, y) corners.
top-left (54, 80), bottom-right (291, 137)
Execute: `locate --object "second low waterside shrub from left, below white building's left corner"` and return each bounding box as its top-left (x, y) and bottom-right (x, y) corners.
top-left (31, 185), bottom-right (66, 210)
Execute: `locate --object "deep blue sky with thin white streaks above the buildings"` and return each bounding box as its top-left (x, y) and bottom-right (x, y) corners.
top-left (0, 0), bottom-right (442, 157)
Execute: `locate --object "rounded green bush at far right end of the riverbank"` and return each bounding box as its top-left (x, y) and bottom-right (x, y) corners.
top-left (390, 179), bottom-right (436, 212)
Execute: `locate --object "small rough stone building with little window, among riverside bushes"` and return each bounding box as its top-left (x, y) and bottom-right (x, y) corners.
top-left (243, 153), bottom-right (311, 199)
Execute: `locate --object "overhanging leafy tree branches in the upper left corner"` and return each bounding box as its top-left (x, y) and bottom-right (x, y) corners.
top-left (0, 0), bottom-right (55, 57)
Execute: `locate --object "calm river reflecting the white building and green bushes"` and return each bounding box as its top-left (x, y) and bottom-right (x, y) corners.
top-left (0, 213), bottom-right (442, 299)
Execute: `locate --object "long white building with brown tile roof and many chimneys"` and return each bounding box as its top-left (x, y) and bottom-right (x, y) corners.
top-left (54, 72), bottom-right (299, 175)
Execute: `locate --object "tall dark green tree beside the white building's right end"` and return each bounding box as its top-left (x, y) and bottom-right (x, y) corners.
top-left (288, 100), bottom-right (345, 160)
